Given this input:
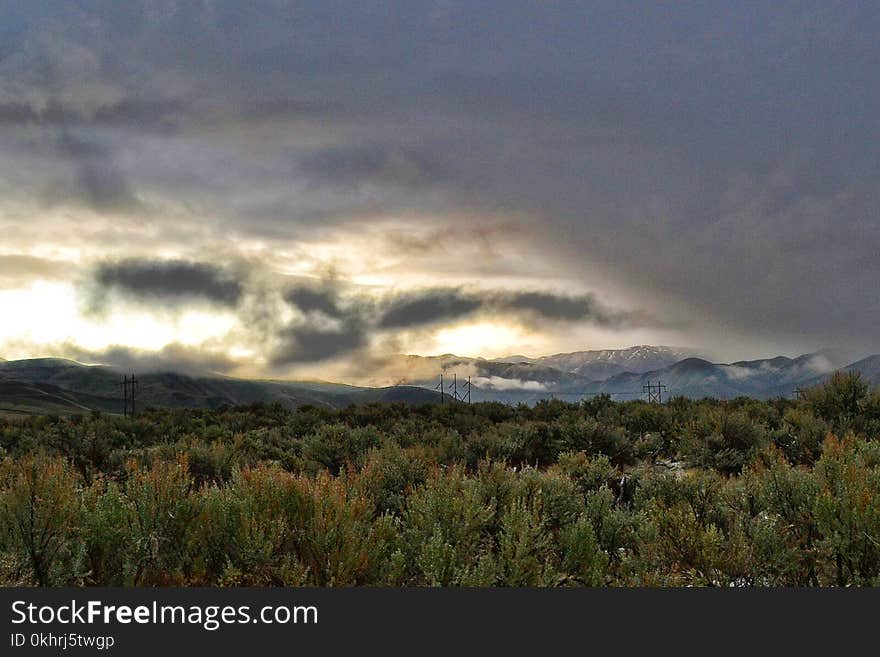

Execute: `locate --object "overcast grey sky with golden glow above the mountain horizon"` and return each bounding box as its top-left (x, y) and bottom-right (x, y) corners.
top-left (0, 0), bottom-right (880, 378)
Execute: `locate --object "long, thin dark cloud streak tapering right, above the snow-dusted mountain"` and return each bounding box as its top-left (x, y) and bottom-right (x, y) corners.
top-left (378, 288), bottom-right (637, 329)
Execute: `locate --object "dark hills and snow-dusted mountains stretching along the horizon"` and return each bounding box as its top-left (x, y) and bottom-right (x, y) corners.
top-left (0, 345), bottom-right (880, 413)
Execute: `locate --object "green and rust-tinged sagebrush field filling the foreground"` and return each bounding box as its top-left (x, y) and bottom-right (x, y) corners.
top-left (0, 375), bottom-right (880, 586)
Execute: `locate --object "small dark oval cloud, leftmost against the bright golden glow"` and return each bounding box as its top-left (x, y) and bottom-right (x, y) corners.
top-left (94, 259), bottom-right (244, 306)
